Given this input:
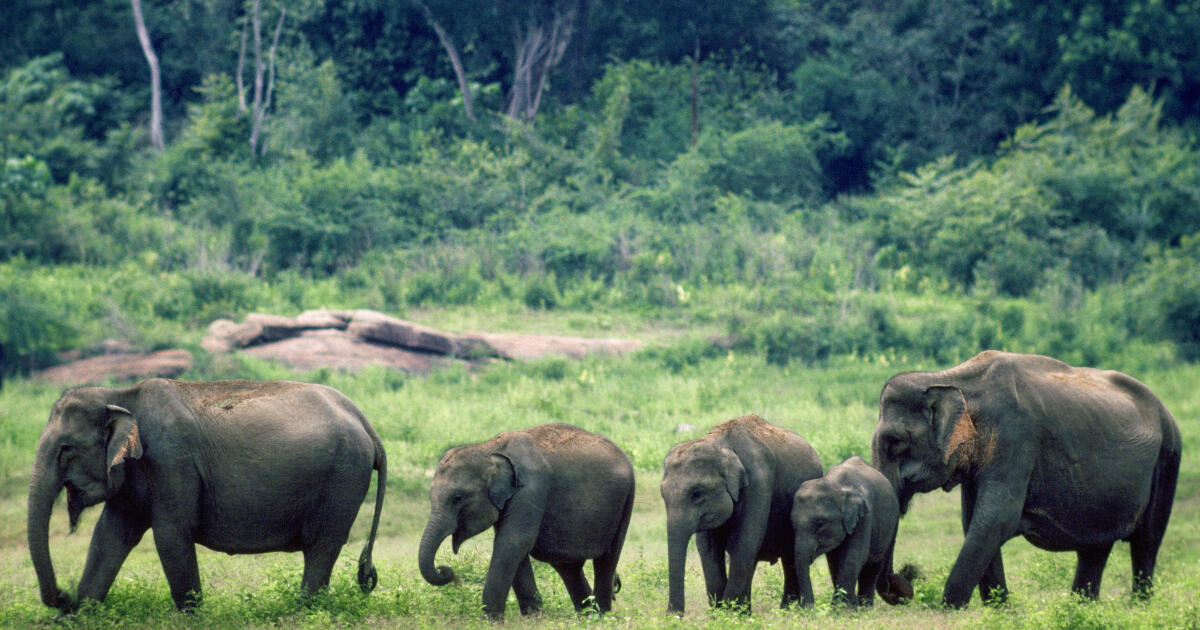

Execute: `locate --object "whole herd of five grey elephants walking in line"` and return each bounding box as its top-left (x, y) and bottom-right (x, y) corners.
top-left (28, 350), bottom-right (1181, 619)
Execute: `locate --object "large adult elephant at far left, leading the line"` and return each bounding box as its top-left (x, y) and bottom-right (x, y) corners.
top-left (28, 379), bottom-right (386, 612)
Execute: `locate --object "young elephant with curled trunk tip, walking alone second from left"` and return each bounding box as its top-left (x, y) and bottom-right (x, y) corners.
top-left (418, 424), bottom-right (634, 620)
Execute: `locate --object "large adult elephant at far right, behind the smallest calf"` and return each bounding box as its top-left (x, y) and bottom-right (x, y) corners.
top-left (871, 350), bottom-right (1181, 607)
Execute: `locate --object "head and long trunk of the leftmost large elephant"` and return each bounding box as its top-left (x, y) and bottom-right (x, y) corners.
top-left (26, 388), bottom-right (142, 608)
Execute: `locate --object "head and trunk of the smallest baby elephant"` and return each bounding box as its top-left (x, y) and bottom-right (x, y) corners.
top-left (792, 478), bottom-right (868, 606)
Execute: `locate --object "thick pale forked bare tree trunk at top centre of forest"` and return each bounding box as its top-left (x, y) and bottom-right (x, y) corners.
top-left (505, 2), bottom-right (578, 121)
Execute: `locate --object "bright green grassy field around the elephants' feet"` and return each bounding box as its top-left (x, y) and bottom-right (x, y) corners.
top-left (0, 343), bottom-right (1200, 629)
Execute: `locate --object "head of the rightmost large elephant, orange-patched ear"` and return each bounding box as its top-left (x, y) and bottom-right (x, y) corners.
top-left (871, 373), bottom-right (995, 514)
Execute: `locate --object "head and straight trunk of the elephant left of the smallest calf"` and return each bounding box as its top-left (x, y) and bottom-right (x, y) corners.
top-left (660, 440), bottom-right (748, 613)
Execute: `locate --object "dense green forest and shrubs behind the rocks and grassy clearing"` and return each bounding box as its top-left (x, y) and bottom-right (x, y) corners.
top-left (0, 0), bottom-right (1200, 374)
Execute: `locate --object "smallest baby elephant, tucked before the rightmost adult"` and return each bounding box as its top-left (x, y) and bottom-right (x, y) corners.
top-left (792, 456), bottom-right (912, 607)
